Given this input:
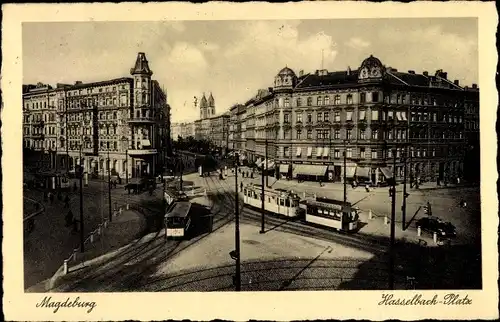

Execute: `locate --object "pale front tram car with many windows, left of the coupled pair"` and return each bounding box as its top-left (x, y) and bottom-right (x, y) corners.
top-left (243, 184), bottom-right (301, 217)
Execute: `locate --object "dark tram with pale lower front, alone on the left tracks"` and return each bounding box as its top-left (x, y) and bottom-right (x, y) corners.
top-left (165, 201), bottom-right (191, 238)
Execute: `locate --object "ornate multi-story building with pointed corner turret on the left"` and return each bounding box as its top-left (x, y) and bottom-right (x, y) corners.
top-left (23, 53), bottom-right (170, 177)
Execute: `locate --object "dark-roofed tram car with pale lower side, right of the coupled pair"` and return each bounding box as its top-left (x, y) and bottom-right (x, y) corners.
top-left (300, 198), bottom-right (359, 232)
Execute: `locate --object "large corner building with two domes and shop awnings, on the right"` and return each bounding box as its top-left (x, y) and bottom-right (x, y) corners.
top-left (244, 56), bottom-right (479, 183)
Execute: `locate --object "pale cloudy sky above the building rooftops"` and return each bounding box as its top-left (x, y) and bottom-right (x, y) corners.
top-left (23, 18), bottom-right (478, 122)
